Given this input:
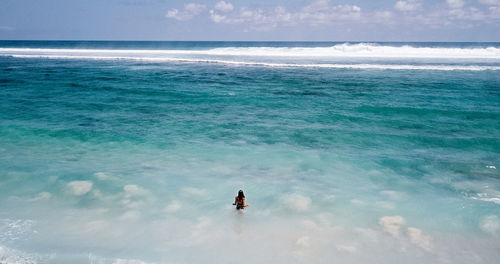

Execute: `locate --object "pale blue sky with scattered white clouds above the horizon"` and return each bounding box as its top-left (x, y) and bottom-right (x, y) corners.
top-left (0, 0), bottom-right (500, 42)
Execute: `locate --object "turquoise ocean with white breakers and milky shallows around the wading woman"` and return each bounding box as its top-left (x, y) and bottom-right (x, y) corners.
top-left (0, 41), bottom-right (500, 264)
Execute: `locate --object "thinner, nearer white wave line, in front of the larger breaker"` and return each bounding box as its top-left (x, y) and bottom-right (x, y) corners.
top-left (4, 54), bottom-right (500, 71)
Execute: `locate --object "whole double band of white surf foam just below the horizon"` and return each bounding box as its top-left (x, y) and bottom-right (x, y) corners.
top-left (0, 43), bottom-right (500, 71)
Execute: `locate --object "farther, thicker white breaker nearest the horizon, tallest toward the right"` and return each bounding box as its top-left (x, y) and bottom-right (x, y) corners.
top-left (0, 43), bottom-right (500, 59)
